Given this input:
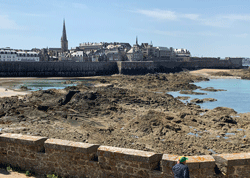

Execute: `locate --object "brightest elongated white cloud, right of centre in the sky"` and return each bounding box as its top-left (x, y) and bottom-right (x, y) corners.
top-left (135, 9), bottom-right (177, 20)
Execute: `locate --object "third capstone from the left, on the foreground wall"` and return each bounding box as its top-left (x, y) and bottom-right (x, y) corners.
top-left (97, 146), bottom-right (162, 163)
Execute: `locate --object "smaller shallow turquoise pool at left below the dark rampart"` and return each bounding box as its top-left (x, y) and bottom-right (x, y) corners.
top-left (11, 79), bottom-right (90, 91)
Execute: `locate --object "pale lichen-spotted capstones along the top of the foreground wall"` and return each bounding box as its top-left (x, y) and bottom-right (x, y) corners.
top-left (0, 133), bottom-right (250, 164)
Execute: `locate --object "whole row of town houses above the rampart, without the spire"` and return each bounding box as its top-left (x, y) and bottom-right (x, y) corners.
top-left (0, 39), bottom-right (190, 62)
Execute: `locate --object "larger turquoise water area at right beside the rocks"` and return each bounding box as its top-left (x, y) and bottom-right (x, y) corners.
top-left (168, 79), bottom-right (250, 113)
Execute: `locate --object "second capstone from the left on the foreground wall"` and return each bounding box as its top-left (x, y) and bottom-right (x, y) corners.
top-left (44, 139), bottom-right (99, 154)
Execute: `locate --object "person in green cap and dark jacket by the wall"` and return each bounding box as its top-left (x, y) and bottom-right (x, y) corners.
top-left (172, 156), bottom-right (189, 178)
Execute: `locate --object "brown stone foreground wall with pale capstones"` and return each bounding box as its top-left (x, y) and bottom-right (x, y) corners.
top-left (0, 133), bottom-right (250, 178)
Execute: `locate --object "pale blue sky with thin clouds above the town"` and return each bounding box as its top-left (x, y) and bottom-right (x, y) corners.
top-left (0, 0), bottom-right (250, 58)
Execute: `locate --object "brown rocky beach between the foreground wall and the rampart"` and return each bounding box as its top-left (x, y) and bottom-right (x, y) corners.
top-left (0, 69), bottom-right (250, 155)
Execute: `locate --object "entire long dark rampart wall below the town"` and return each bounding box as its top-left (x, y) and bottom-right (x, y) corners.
top-left (0, 58), bottom-right (242, 77)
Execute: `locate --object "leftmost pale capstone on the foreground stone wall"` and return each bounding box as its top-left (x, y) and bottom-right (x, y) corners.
top-left (0, 133), bottom-right (48, 146)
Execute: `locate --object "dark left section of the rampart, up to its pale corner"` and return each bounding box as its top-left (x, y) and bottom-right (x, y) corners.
top-left (0, 62), bottom-right (118, 77)
